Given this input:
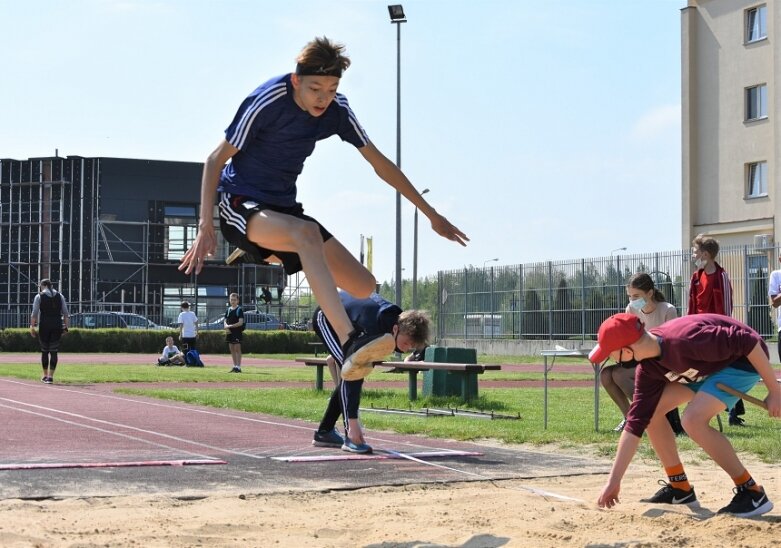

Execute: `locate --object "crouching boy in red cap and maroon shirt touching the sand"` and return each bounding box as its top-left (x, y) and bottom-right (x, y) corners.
top-left (589, 313), bottom-right (781, 517)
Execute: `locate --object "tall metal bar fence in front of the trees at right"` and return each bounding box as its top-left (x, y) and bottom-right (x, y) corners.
top-left (437, 246), bottom-right (779, 341)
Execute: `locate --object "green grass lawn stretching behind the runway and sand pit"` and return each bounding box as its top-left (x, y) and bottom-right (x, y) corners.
top-left (0, 356), bottom-right (781, 462)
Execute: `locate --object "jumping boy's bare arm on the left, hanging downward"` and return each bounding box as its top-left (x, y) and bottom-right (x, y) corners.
top-left (179, 139), bottom-right (239, 274)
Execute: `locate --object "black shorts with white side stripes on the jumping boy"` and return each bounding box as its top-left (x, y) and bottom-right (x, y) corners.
top-left (219, 192), bottom-right (333, 275)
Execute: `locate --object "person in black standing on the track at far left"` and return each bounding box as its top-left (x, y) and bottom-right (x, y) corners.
top-left (30, 279), bottom-right (68, 384)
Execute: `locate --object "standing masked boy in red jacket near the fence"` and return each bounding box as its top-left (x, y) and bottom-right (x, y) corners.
top-left (688, 234), bottom-right (746, 426)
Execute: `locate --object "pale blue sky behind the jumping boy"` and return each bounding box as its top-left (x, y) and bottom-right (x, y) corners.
top-left (0, 0), bottom-right (685, 282)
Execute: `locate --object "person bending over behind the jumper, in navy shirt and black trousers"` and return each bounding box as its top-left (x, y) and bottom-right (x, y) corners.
top-left (312, 291), bottom-right (431, 453)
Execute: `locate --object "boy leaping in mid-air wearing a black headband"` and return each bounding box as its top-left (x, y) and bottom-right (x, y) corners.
top-left (179, 38), bottom-right (468, 372)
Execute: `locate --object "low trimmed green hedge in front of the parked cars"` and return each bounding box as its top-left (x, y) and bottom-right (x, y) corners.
top-left (0, 328), bottom-right (318, 354)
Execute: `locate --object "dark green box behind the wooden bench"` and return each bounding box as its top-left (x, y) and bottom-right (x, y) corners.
top-left (423, 346), bottom-right (477, 400)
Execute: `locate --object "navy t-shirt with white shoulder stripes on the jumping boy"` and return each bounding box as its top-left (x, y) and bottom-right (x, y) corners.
top-left (217, 74), bottom-right (369, 207)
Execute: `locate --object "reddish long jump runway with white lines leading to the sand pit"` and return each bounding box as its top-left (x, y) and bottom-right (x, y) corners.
top-left (0, 378), bottom-right (609, 499)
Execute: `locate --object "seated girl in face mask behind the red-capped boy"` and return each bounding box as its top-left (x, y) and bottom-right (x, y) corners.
top-left (599, 272), bottom-right (683, 435)
